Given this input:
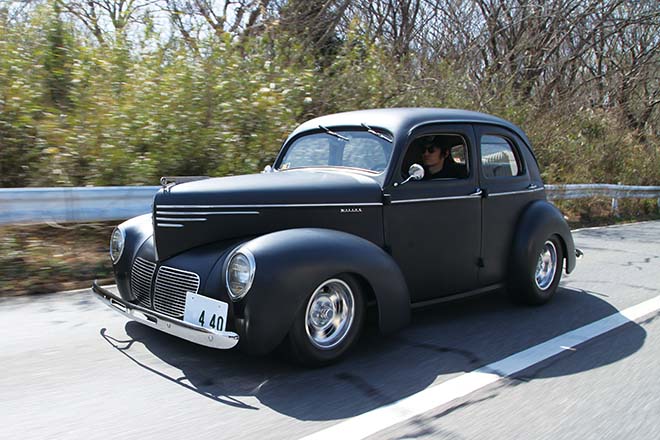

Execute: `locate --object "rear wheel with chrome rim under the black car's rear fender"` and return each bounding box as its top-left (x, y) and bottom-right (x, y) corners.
top-left (509, 235), bottom-right (564, 305)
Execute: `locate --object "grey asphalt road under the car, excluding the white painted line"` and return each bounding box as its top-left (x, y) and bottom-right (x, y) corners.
top-left (0, 222), bottom-right (660, 439)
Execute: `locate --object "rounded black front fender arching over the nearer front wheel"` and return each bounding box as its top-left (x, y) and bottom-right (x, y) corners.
top-left (235, 228), bottom-right (410, 353)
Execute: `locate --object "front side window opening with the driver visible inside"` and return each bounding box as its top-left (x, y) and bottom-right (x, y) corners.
top-left (401, 134), bottom-right (470, 180)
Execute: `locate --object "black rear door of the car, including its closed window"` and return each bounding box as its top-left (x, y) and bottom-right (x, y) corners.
top-left (474, 124), bottom-right (543, 285)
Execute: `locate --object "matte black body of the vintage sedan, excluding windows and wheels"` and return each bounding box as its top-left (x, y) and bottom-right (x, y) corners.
top-left (99, 109), bottom-right (576, 360)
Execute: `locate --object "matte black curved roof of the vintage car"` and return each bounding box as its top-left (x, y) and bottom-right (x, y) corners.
top-left (289, 108), bottom-right (530, 146)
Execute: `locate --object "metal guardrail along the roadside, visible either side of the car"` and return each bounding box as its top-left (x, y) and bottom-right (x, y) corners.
top-left (0, 184), bottom-right (660, 225)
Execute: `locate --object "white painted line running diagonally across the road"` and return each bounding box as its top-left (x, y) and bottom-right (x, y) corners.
top-left (302, 296), bottom-right (660, 440)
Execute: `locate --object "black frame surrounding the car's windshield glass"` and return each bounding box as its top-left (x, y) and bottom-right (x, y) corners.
top-left (273, 125), bottom-right (396, 177)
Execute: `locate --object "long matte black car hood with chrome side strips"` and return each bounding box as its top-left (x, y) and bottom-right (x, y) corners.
top-left (153, 169), bottom-right (382, 260)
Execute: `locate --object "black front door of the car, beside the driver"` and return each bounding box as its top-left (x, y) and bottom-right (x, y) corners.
top-left (383, 124), bottom-right (481, 302)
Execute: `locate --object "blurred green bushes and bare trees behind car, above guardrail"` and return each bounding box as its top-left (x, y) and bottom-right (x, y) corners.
top-left (0, 0), bottom-right (660, 187)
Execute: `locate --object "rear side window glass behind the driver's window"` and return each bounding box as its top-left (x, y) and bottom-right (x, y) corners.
top-left (481, 134), bottom-right (522, 178)
